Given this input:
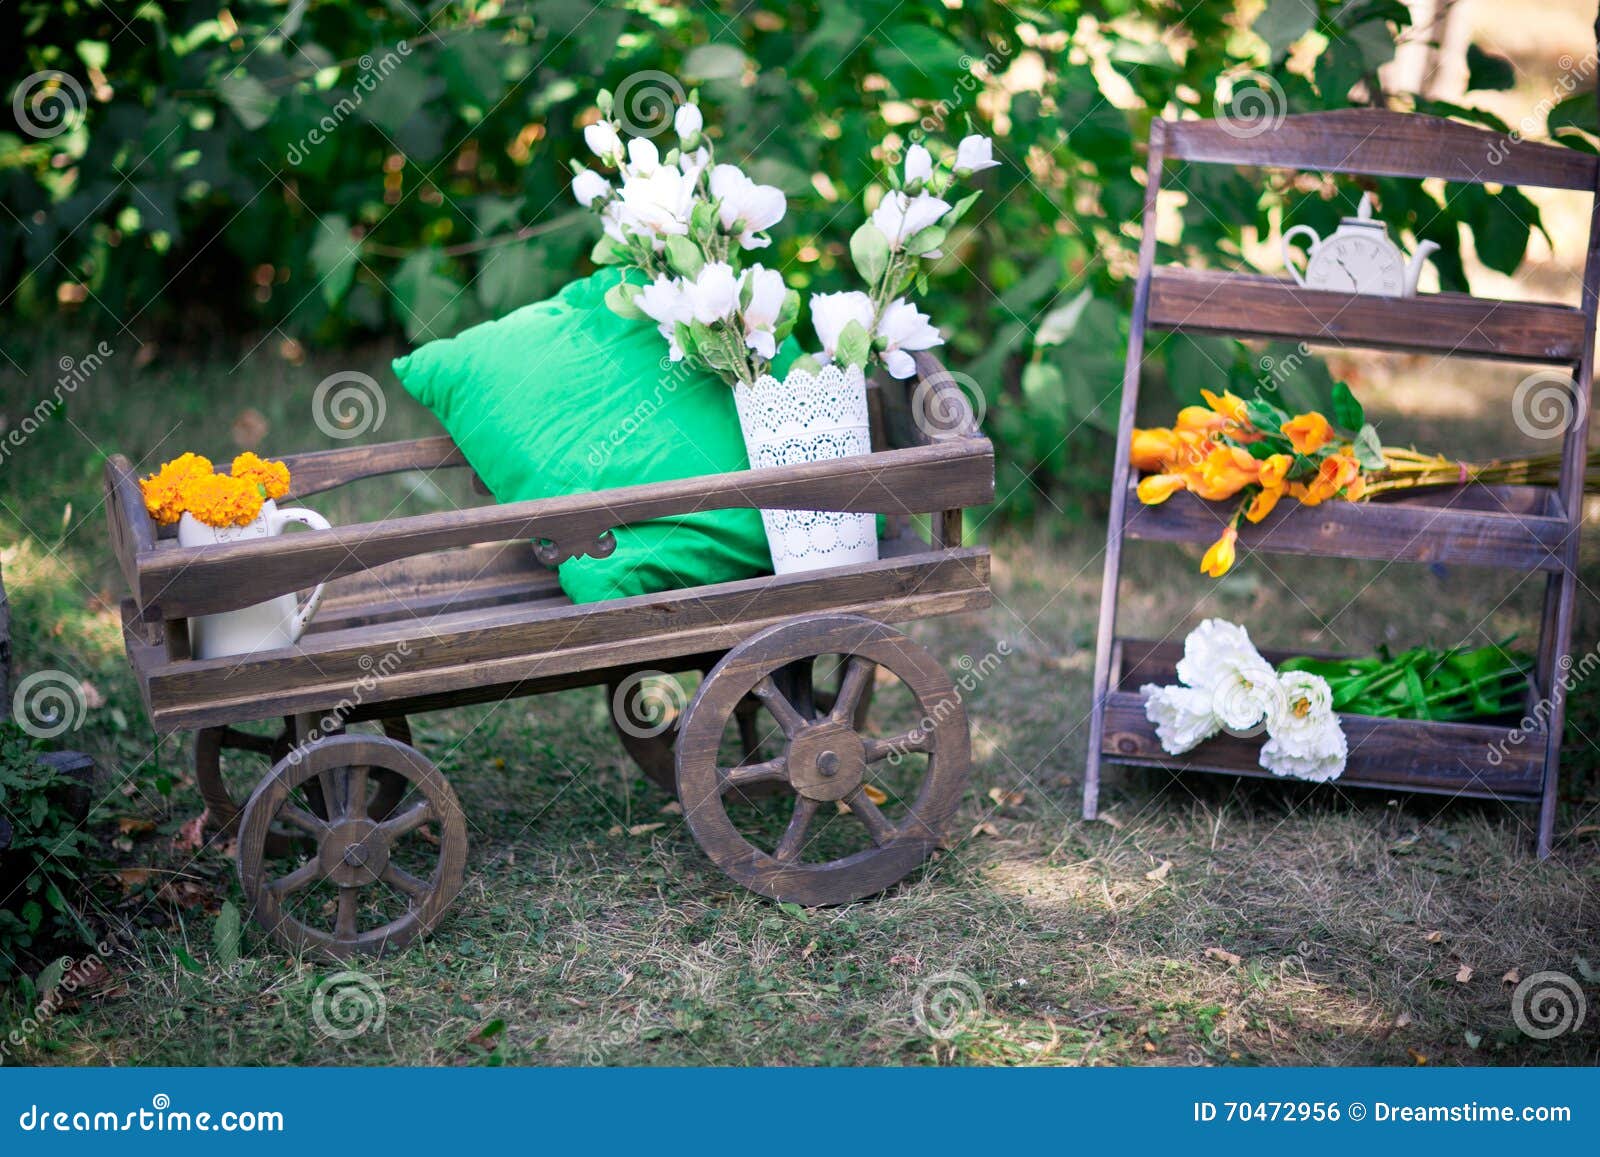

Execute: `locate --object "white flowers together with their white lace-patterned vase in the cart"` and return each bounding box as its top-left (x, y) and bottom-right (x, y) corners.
top-left (573, 93), bottom-right (997, 573)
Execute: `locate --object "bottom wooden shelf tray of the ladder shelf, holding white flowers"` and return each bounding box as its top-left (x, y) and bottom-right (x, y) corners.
top-left (1101, 639), bottom-right (1544, 800)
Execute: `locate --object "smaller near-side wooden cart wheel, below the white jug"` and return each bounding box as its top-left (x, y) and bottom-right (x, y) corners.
top-left (238, 735), bottom-right (467, 960)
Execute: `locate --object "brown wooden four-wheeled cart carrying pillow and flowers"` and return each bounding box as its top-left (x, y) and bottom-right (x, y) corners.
top-left (106, 357), bottom-right (994, 957)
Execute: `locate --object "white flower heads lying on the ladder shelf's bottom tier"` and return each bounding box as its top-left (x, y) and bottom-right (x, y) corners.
top-left (1139, 619), bottom-right (1349, 783)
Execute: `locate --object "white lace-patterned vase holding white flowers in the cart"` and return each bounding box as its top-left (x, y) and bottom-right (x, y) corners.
top-left (733, 365), bottom-right (878, 574)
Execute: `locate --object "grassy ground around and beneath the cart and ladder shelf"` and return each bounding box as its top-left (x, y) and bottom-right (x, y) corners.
top-left (0, 332), bottom-right (1600, 1064)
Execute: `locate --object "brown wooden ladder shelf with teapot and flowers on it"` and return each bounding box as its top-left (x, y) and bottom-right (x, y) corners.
top-left (1083, 109), bottom-right (1600, 856)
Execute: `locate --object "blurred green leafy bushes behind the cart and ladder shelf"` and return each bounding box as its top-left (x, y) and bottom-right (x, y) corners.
top-left (0, 0), bottom-right (1589, 515)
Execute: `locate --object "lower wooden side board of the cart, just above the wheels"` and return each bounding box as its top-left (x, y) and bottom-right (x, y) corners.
top-left (140, 549), bottom-right (989, 731)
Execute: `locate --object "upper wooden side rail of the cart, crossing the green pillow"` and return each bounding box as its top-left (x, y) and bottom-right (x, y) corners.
top-left (136, 438), bottom-right (994, 619)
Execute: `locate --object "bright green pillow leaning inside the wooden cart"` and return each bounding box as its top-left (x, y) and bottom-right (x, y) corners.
top-left (394, 269), bottom-right (773, 603)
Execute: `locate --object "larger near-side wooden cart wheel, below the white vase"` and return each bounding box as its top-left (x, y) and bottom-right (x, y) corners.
top-left (677, 615), bottom-right (971, 906)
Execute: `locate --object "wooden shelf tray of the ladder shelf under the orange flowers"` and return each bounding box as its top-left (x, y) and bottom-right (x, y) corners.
top-left (1123, 482), bottom-right (1570, 571)
